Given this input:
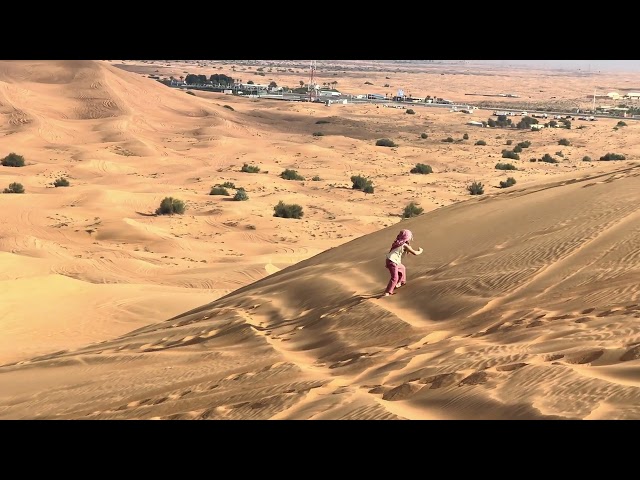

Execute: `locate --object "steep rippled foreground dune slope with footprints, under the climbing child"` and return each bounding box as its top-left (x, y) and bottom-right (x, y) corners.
top-left (0, 165), bottom-right (640, 419)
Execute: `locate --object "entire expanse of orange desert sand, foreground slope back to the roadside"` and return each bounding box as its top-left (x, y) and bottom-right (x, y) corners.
top-left (0, 61), bottom-right (640, 419)
